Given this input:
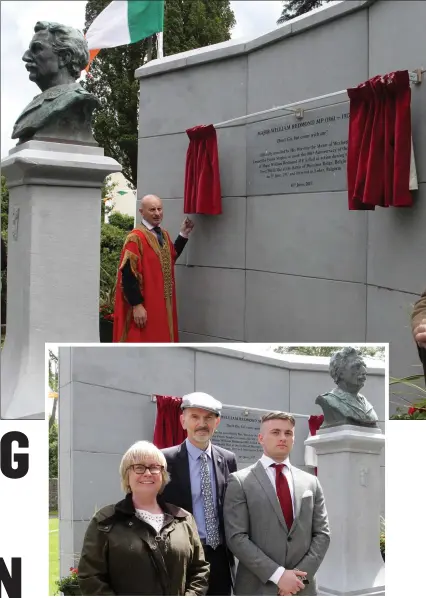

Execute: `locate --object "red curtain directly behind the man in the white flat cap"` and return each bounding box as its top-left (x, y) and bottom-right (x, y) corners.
top-left (153, 395), bottom-right (186, 449)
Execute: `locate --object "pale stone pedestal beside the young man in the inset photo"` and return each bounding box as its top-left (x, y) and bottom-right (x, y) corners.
top-left (305, 425), bottom-right (385, 596)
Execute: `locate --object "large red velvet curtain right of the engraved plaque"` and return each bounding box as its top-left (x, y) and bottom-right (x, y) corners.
top-left (347, 71), bottom-right (412, 210)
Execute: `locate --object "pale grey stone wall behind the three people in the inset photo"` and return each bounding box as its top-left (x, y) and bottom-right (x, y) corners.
top-left (59, 346), bottom-right (386, 575)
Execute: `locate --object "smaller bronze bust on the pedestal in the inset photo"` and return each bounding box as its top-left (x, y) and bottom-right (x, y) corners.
top-left (315, 347), bottom-right (378, 428)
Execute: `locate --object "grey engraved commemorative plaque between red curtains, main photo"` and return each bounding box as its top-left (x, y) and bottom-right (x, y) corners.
top-left (247, 102), bottom-right (349, 195)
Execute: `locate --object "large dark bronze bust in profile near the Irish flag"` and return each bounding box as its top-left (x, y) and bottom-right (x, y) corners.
top-left (12, 21), bottom-right (99, 145)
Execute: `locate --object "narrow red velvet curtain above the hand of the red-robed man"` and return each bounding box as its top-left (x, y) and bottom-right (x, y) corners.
top-left (184, 125), bottom-right (222, 215)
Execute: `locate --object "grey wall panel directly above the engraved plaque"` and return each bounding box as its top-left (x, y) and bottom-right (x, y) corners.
top-left (247, 11), bottom-right (368, 113)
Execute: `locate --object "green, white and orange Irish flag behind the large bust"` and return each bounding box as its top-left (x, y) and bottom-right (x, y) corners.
top-left (86, 0), bottom-right (164, 68)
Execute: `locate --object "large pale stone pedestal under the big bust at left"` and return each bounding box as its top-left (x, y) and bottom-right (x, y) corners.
top-left (0, 140), bottom-right (121, 419)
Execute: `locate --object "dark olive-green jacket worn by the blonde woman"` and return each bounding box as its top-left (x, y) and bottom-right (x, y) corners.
top-left (78, 494), bottom-right (210, 596)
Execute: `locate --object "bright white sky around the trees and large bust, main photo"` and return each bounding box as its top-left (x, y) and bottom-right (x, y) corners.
top-left (1, 0), bottom-right (282, 158)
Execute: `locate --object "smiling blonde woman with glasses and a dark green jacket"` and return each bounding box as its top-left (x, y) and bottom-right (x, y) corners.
top-left (78, 441), bottom-right (209, 596)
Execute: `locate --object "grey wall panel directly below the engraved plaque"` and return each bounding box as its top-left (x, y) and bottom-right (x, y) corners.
top-left (247, 192), bottom-right (367, 284)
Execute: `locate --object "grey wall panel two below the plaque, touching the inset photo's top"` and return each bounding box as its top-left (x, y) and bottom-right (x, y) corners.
top-left (245, 271), bottom-right (368, 343)
